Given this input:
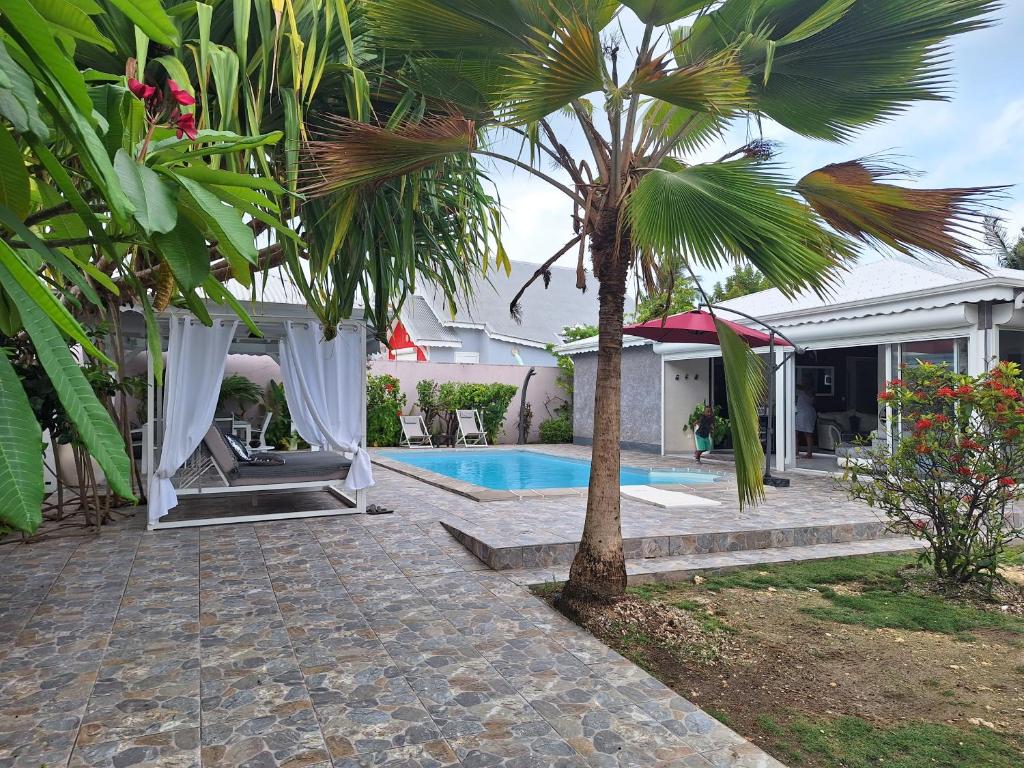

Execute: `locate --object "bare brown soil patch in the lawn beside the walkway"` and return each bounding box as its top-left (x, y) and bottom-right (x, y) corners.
top-left (548, 585), bottom-right (1024, 765)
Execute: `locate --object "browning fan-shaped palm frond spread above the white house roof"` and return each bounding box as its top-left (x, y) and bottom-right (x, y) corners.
top-left (796, 159), bottom-right (996, 269)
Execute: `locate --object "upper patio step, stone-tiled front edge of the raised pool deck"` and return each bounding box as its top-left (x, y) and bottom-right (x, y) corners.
top-left (440, 518), bottom-right (895, 571)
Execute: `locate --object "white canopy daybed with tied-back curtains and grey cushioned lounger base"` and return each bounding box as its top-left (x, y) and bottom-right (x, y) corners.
top-left (143, 303), bottom-right (374, 530)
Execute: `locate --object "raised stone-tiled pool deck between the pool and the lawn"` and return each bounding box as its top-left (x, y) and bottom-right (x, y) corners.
top-left (374, 445), bottom-right (914, 584)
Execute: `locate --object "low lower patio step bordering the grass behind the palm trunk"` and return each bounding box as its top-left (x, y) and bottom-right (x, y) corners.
top-left (502, 537), bottom-right (921, 586)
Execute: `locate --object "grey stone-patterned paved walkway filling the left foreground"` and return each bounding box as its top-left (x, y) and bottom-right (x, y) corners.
top-left (0, 470), bottom-right (779, 768)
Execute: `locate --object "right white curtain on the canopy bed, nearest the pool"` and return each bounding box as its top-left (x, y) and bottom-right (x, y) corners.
top-left (281, 323), bottom-right (374, 490)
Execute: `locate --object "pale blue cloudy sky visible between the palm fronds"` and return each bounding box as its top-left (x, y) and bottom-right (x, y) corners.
top-left (490, 0), bottom-right (1024, 288)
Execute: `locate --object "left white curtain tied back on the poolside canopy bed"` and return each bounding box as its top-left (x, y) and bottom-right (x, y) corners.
top-left (150, 317), bottom-right (239, 522)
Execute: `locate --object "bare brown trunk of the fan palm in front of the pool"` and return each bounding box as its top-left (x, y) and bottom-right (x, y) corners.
top-left (559, 234), bottom-right (629, 615)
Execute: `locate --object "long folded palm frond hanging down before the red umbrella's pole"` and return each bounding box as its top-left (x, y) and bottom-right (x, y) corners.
top-left (715, 317), bottom-right (766, 509)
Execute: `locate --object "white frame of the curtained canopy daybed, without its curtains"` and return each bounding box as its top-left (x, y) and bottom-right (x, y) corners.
top-left (136, 302), bottom-right (367, 530)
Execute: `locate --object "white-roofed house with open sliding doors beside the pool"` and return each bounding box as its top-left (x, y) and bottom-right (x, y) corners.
top-left (558, 258), bottom-right (1024, 469)
